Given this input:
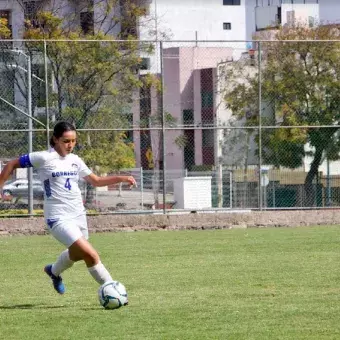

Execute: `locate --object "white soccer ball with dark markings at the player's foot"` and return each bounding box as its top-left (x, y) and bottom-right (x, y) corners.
top-left (98, 281), bottom-right (128, 309)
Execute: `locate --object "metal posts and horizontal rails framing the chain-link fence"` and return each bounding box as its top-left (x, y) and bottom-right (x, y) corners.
top-left (0, 40), bottom-right (339, 215)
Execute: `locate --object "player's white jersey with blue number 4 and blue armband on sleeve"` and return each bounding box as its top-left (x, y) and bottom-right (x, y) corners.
top-left (19, 149), bottom-right (92, 224)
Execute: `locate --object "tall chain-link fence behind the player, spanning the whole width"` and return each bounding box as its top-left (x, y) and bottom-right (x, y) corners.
top-left (0, 40), bottom-right (340, 215)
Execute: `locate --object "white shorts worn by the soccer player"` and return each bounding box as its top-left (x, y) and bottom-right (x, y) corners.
top-left (48, 215), bottom-right (89, 248)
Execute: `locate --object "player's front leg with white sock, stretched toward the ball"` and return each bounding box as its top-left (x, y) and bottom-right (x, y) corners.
top-left (69, 237), bottom-right (112, 285)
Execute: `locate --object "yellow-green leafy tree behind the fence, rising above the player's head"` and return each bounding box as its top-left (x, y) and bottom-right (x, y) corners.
top-left (0, 0), bottom-right (152, 171)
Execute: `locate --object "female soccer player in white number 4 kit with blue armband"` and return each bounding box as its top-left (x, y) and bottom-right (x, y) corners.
top-left (0, 122), bottom-right (136, 294)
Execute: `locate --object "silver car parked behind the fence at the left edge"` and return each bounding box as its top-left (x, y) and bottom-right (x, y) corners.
top-left (2, 179), bottom-right (44, 199)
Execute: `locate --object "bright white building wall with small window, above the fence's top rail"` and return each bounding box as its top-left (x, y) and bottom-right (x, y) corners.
top-left (140, 0), bottom-right (247, 40)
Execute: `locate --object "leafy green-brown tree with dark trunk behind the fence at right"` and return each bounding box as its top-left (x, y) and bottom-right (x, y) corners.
top-left (225, 23), bottom-right (340, 206)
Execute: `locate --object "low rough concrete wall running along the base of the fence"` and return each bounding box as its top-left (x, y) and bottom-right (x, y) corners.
top-left (0, 209), bottom-right (340, 236)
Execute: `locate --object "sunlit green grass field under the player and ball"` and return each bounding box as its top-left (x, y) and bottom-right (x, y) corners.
top-left (0, 227), bottom-right (340, 340)
